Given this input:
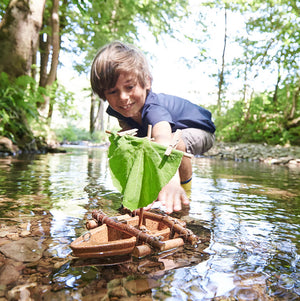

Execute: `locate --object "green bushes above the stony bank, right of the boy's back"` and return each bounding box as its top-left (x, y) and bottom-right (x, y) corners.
top-left (211, 83), bottom-right (300, 145)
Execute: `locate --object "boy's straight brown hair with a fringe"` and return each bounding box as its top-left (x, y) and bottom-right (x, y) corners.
top-left (91, 41), bottom-right (152, 100)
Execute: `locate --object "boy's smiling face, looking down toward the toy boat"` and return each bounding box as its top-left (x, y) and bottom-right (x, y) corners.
top-left (104, 73), bottom-right (150, 122)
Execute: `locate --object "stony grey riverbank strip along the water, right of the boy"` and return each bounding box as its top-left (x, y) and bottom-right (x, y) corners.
top-left (204, 142), bottom-right (300, 168)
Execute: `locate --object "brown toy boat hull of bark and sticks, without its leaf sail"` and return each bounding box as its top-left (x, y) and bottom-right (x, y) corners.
top-left (70, 209), bottom-right (199, 258)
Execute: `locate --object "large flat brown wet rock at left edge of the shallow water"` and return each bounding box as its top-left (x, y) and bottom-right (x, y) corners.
top-left (0, 238), bottom-right (45, 262)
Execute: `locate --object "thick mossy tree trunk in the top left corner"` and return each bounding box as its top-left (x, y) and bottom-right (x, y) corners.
top-left (0, 0), bottom-right (46, 78)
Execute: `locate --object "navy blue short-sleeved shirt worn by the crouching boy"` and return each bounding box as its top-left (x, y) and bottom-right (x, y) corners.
top-left (106, 91), bottom-right (216, 137)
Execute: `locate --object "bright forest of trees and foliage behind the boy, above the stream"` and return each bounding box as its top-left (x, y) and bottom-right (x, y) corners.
top-left (0, 0), bottom-right (300, 151)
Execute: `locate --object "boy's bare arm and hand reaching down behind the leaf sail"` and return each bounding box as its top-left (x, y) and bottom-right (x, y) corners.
top-left (152, 121), bottom-right (189, 213)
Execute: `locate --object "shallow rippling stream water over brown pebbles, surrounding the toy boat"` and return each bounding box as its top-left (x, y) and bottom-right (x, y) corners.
top-left (0, 148), bottom-right (300, 301)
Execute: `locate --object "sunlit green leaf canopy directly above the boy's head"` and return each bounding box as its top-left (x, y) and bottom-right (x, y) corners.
top-left (61, 0), bottom-right (188, 72)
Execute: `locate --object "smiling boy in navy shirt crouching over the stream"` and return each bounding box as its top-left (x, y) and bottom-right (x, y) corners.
top-left (91, 42), bottom-right (215, 213)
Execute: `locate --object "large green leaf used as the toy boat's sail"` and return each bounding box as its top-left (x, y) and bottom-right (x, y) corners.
top-left (108, 134), bottom-right (183, 210)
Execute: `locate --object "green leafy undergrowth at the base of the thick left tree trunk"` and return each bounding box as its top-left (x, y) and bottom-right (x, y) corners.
top-left (0, 73), bottom-right (45, 144)
